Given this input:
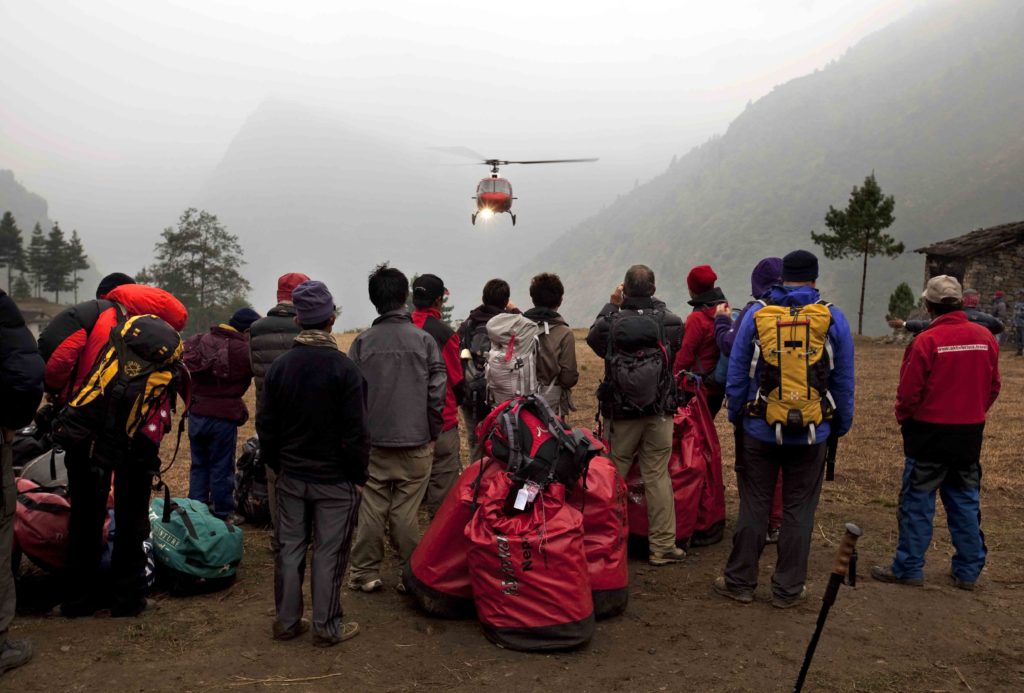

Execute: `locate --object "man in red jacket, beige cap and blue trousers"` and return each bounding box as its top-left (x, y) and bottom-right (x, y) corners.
top-left (871, 274), bottom-right (999, 590)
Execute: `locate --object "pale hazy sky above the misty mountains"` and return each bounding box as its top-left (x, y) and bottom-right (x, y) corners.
top-left (0, 0), bottom-right (921, 280)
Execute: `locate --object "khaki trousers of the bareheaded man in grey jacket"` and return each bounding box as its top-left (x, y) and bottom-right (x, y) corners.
top-left (350, 443), bottom-right (434, 582)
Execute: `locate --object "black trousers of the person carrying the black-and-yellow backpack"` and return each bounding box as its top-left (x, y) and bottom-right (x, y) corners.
top-left (65, 450), bottom-right (153, 614)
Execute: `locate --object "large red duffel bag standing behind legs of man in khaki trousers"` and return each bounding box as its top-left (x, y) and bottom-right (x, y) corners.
top-left (626, 390), bottom-right (725, 554)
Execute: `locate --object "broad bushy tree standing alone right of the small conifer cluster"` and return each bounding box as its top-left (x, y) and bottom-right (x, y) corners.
top-left (139, 208), bottom-right (250, 331)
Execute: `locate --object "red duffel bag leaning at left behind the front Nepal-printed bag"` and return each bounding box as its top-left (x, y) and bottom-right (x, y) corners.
top-left (402, 459), bottom-right (502, 618)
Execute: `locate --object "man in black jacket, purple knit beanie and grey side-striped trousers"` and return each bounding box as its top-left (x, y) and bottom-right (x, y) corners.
top-left (256, 281), bottom-right (370, 647)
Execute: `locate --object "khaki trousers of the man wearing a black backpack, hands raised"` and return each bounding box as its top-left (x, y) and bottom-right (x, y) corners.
top-left (608, 416), bottom-right (676, 553)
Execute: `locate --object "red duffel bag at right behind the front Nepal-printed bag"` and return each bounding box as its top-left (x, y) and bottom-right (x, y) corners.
top-left (573, 457), bottom-right (630, 618)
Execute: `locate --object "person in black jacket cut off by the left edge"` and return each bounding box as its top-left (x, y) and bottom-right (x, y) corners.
top-left (0, 291), bottom-right (44, 674)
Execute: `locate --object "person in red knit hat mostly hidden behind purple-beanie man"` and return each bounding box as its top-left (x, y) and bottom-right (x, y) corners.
top-left (249, 272), bottom-right (309, 524)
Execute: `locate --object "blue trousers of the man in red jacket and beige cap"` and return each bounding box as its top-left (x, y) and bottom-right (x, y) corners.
top-left (892, 458), bottom-right (988, 582)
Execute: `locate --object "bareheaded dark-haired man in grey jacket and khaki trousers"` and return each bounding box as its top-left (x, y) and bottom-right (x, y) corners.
top-left (348, 263), bottom-right (447, 592)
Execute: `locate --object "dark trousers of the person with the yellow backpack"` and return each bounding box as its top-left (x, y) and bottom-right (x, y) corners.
top-left (725, 433), bottom-right (825, 598)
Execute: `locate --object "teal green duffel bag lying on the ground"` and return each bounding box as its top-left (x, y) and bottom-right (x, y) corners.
top-left (150, 497), bottom-right (243, 595)
